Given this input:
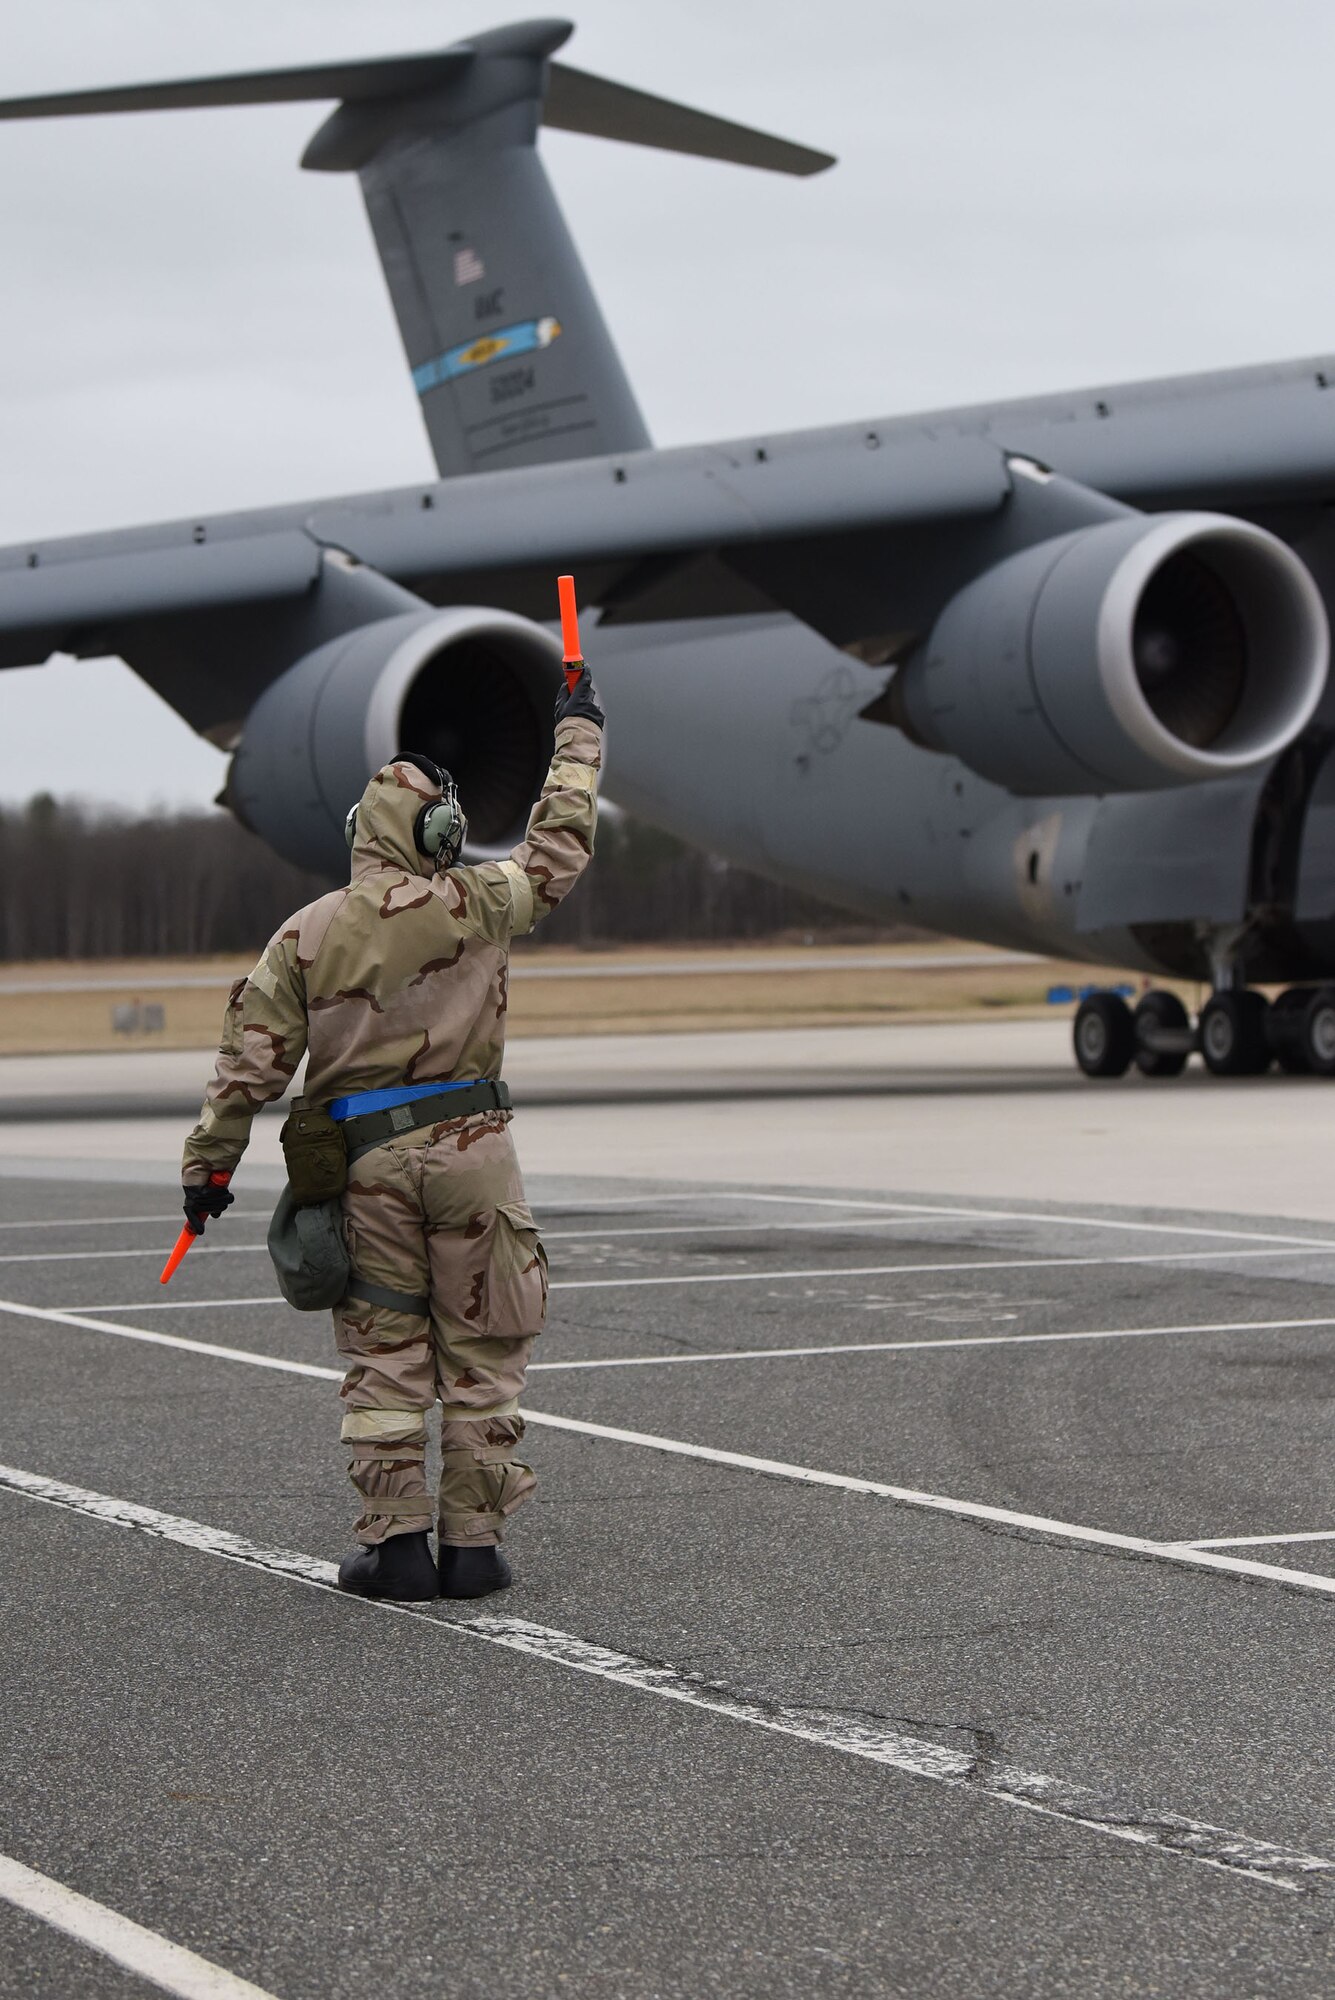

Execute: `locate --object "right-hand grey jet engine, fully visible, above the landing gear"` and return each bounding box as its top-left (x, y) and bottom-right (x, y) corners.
top-left (891, 514), bottom-right (1329, 796)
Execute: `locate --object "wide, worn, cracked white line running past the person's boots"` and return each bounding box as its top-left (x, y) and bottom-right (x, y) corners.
top-left (0, 1466), bottom-right (1335, 1896)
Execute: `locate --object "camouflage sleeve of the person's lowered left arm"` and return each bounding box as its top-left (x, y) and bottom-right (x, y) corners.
top-left (182, 918), bottom-right (306, 1188)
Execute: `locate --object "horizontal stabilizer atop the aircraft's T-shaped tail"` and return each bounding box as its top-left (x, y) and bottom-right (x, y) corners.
top-left (0, 20), bottom-right (833, 174)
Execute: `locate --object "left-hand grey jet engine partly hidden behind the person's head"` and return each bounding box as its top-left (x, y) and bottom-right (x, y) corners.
top-left (226, 606), bottom-right (562, 876)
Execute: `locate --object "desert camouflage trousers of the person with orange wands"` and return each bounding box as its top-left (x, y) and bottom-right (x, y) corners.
top-left (334, 1112), bottom-right (548, 1548)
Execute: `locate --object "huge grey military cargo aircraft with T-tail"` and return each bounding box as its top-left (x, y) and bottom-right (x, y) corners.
top-left (0, 20), bottom-right (1335, 1076)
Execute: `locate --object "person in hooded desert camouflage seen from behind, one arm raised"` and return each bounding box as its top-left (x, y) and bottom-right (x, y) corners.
top-left (182, 668), bottom-right (604, 1598)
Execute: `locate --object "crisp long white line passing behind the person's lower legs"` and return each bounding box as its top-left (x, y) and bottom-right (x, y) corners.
top-left (0, 1300), bottom-right (1335, 1596)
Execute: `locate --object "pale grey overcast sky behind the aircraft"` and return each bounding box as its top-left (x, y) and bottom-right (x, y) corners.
top-left (0, 0), bottom-right (1335, 804)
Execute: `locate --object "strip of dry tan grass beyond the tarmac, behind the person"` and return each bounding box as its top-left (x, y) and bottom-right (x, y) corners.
top-left (0, 940), bottom-right (1193, 1056)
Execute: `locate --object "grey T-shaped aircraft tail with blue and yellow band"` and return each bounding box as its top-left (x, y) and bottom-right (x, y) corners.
top-left (0, 20), bottom-right (833, 476)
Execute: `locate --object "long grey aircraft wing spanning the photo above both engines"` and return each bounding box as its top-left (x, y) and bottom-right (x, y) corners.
top-left (0, 362), bottom-right (1335, 728)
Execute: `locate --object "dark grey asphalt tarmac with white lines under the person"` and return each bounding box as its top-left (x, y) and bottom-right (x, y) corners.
top-left (0, 1040), bottom-right (1335, 2000)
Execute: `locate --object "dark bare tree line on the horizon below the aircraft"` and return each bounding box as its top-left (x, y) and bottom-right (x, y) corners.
top-left (0, 794), bottom-right (887, 960)
